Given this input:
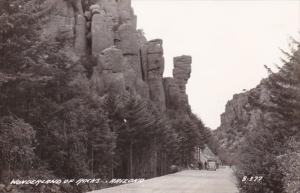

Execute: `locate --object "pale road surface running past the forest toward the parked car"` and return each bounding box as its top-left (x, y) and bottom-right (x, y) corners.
top-left (89, 167), bottom-right (238, 193)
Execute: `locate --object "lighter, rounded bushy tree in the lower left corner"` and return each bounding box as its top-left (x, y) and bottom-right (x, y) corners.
top-left (0, 115), bottom-right (36, 181)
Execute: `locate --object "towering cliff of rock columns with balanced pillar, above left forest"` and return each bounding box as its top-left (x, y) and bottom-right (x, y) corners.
top-left (42, 0), bottom-right (192, 111)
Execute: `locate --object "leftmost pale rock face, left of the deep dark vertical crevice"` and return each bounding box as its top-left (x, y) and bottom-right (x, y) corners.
top-left (41, 0), bottom-right (86, 62)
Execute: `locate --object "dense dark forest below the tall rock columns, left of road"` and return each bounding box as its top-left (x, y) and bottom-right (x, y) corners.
top-left (0, 0), bottom-right (213, 193)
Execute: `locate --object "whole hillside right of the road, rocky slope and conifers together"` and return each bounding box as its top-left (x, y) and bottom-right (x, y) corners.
top-left (215, 40), bottom-right (300, 193)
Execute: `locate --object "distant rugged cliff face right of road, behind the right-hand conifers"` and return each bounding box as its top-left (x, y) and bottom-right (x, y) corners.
top-left (215, 81), bottom-right (270, 153)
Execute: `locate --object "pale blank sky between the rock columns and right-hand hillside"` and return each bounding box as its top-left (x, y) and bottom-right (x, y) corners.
top-left (132, 0), bottom-right (300, 129)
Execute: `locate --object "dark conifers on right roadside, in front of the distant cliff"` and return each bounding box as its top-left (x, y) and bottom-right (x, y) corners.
top-left (238, 44), bottom-right (300, 193)
